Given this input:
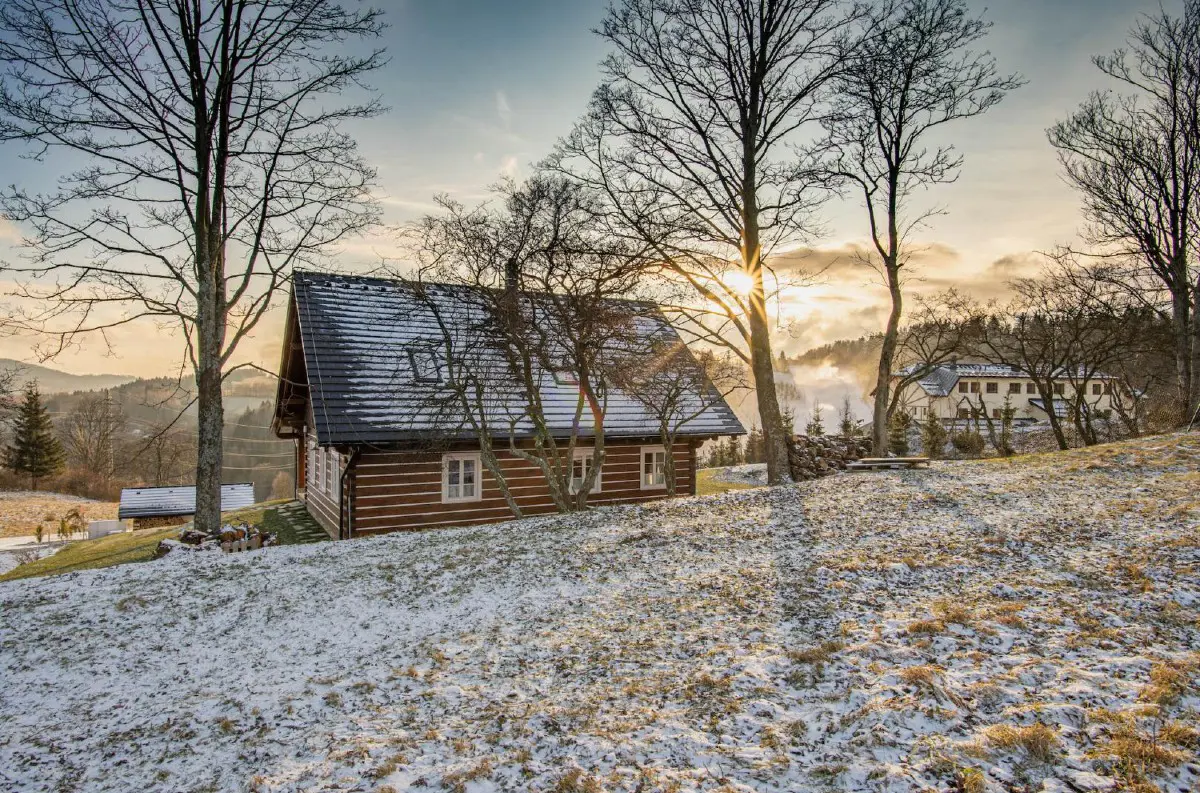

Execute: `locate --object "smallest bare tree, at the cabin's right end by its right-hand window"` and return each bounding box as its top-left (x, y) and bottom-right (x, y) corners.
top-left (614, 340), bottom-right (749, 495)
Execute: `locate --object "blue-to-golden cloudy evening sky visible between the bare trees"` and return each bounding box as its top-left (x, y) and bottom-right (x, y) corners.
top-left (0, 0), bottom-right (1171, 376)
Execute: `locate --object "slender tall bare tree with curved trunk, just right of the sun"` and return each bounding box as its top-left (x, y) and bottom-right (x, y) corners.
top-left (826, 0), bottom-right (1021, 455)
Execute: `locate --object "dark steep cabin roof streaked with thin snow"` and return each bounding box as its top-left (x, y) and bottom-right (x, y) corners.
top-left (275, 272), bottom-right (745, 446)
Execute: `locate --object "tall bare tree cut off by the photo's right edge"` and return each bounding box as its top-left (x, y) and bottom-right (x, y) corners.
top-left (1049, 0), bottom-right (1200, 413)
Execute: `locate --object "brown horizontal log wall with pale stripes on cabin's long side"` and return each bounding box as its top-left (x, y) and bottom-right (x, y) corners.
top-left (353, 441), bottom-right (695, 535)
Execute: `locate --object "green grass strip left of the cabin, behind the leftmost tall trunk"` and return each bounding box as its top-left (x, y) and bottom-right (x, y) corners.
top-left (0, 500), bottom-right (329, 581)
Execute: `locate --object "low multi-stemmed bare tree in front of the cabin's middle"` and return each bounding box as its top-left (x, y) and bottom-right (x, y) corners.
top-left (415, 175), bottom-right (646, 515)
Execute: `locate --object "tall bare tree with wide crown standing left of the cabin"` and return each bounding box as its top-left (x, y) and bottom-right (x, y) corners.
top-left (0, 0), bottom-right (383, 530)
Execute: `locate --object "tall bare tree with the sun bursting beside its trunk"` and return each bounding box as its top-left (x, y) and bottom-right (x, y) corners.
top-left (552, 0), bottom-right (852, 483)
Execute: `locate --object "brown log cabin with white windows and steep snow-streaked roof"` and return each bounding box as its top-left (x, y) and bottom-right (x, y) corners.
top-left (272, 272), bottom-right (745, 539)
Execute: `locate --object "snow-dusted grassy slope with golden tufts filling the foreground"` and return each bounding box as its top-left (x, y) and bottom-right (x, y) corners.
top-left (0, 435), bottom-right (1200, 793)
